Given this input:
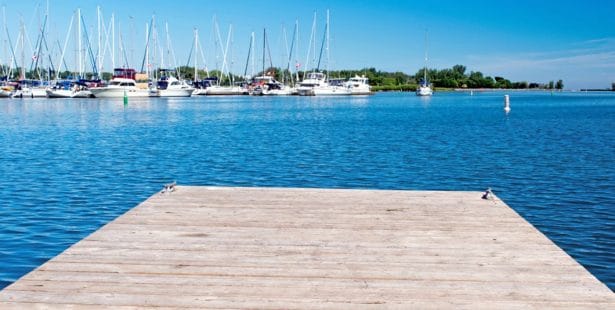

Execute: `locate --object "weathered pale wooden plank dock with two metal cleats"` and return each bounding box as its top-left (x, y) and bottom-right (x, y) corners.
top-left (0, 186), bottom-right (615, 309)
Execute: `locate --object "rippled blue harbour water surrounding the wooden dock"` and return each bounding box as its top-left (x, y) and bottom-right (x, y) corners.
top-left (0, 93), bottom-right (615, 289)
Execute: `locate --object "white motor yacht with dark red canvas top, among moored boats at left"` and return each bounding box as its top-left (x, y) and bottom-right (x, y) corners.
top-left (90, 68), bottom-right (149, 98)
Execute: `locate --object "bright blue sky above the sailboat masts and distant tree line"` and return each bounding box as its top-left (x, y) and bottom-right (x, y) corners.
top-left (0, 0), bottom-right (615, 89)
